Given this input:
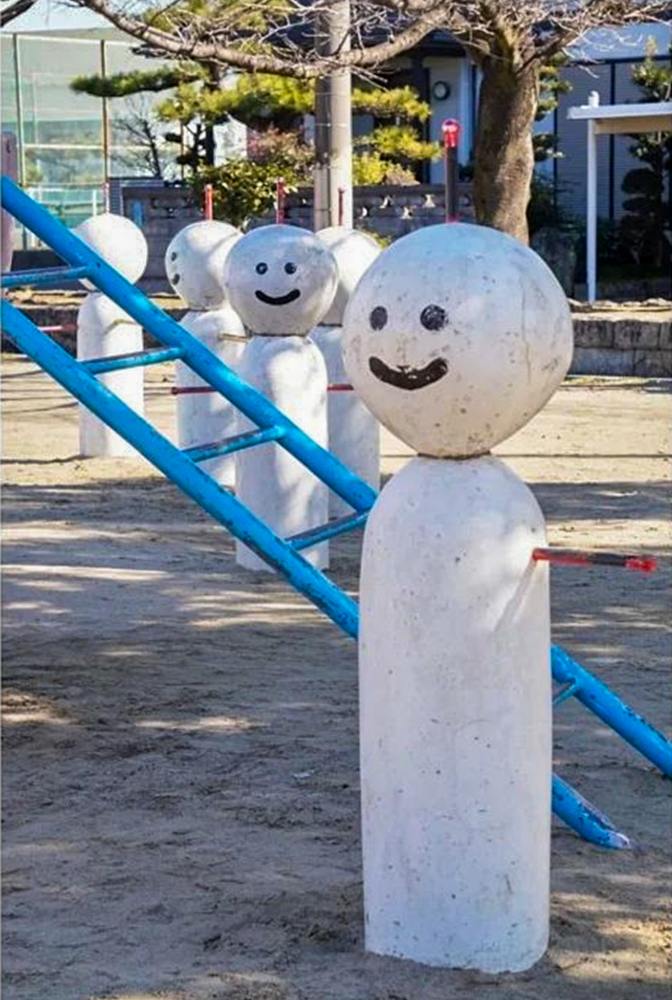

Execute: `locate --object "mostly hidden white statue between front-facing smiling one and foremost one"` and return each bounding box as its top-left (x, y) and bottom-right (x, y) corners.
top-left (310, 226), bottom-right (380, 517)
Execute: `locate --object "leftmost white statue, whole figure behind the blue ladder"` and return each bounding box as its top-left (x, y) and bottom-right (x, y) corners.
top-left (74, 212), bottom-right (147, 457)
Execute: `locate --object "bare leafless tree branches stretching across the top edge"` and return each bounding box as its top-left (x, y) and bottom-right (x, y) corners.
top-left (71, 0), bottom-right (670, 79)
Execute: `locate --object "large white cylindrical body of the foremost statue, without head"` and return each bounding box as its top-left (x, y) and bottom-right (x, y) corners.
top-left (359, 456), bottom-right (551, 973)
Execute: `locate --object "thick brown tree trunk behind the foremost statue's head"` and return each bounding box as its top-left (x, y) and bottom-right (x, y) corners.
top-left (474, 52), bottom-right (539, 243)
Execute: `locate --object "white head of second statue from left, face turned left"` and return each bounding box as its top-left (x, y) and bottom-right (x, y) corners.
top-left (164, 219), bottom-right (240, 309)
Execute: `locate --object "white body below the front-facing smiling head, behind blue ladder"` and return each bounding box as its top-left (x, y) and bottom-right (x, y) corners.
top-left (236, 336), bottom-right (329, 570)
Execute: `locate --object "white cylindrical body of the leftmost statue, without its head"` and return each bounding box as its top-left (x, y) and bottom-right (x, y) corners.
top-left (77, 292), bottom-right (144, 458)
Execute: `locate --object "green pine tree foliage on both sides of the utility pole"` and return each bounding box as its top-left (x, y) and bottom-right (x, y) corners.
top-left (71, 64), bottom-right (441, 225)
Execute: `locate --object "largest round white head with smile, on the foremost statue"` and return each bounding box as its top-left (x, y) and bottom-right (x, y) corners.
top-left (343, 223), bottom-right (573, 458)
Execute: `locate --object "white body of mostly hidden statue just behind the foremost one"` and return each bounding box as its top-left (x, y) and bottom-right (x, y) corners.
top-left (310, 325), bottom-right (380, 517)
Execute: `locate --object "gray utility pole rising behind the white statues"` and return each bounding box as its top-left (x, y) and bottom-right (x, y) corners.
top-left (314, 0), bottom-right (352, 229)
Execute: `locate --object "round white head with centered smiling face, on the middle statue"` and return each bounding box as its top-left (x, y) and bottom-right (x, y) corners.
top-left (224, 225), bottom-right (338, 336)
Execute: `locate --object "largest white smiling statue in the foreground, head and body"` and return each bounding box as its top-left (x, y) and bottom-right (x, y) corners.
top-left (343, 223), bottom-right (572, 973)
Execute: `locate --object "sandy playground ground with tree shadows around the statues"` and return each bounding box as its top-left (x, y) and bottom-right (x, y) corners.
top-left (3, 357), bottom-right (671, 1000)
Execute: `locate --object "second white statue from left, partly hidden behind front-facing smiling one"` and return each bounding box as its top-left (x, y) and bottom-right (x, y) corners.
top-left (165, 221), bottom-right (245, 488)
